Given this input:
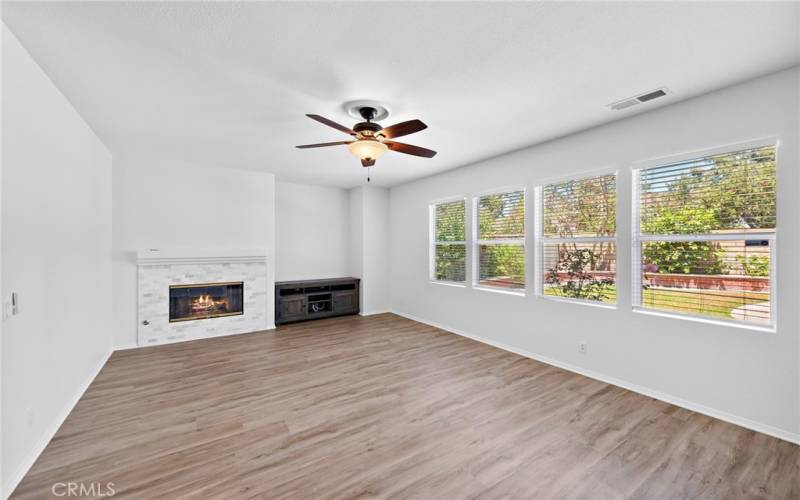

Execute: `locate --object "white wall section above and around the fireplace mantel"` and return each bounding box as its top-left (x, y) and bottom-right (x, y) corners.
top-left (113, 158), bottom-right (275, 348)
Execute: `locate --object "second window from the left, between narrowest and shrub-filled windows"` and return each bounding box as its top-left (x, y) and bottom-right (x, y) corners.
top-left (474, 189), bottom-right (525, 291)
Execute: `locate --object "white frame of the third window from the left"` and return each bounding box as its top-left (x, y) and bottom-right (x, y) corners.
top-left (534, 169), bottom-right (619, 309)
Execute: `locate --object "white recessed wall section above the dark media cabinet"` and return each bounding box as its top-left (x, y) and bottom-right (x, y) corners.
top-left (275, 182), bottom-right (350, 281)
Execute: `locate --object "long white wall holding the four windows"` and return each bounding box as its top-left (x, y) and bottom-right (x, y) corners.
top-left (390, 68), bottom-right (800, 441)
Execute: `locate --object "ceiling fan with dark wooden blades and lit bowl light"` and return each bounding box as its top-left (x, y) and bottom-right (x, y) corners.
top-left (297, 106), bottom-right (436, 167)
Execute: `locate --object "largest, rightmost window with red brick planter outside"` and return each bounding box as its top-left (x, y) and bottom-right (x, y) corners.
top-left (633, 146), bottom-right (776, 325)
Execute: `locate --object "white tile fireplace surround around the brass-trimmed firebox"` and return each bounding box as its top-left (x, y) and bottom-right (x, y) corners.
top-left (136, 250), bottom-right (271, 346)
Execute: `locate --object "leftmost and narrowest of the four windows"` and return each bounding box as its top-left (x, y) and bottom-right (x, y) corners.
top-left (431, 199), bottom-right (467, 283)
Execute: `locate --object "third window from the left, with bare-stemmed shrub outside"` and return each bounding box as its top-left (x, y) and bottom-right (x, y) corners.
top-left (537, 174), bottom-right (617, 304)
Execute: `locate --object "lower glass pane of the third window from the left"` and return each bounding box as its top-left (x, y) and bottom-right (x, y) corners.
top-left (543, 241), bottom-right (617, 304)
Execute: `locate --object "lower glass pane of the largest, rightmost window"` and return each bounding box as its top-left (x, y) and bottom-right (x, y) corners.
top-left (641, 240), bottom-right (771, 324)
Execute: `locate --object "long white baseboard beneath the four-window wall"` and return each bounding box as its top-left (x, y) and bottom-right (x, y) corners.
top-left (392, 311), bottom-right (800, 444)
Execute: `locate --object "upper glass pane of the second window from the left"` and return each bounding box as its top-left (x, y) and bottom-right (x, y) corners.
top-left (478, 191), bottom-right (525, 240)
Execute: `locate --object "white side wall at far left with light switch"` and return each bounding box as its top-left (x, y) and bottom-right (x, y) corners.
top-left (0, 26), bottom-right (112, 496)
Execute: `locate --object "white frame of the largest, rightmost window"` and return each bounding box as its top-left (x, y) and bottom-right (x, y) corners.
top-left (631, 137), bottom-right (780, 333)
